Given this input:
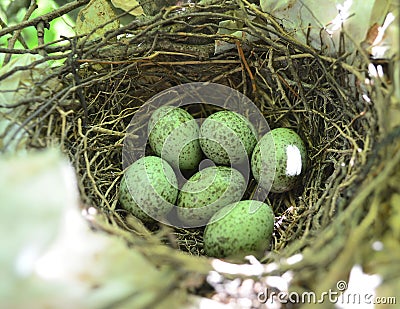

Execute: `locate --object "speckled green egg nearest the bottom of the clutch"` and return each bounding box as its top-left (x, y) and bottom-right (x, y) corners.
top-left (203, 200), bottom-right (275, 258)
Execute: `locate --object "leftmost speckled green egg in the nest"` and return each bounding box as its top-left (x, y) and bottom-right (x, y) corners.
top-left (119, 156), bottom-right (178, 223)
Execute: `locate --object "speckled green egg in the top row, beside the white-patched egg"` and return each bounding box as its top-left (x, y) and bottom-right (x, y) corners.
top-left (200, 111), bottom-right (257, 165)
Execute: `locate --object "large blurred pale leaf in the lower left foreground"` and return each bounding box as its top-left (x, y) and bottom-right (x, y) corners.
top-left (0, 149), bottom-right (181, 309)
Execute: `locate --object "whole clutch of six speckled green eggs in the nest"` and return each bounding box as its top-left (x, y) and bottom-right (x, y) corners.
top-left (119, 106), bottom-right (307, 257)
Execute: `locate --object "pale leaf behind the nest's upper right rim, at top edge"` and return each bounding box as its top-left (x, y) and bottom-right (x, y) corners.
top-left (260, 0), bottom-right (375, 54)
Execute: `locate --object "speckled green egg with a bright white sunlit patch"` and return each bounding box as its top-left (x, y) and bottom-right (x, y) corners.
top-left (251, 128), bottom-right (307, 193)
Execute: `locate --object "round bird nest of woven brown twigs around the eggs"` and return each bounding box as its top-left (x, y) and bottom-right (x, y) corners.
top-left (1, 1), bottom-right (398, 306)
